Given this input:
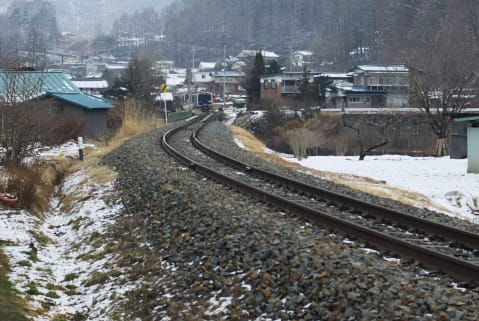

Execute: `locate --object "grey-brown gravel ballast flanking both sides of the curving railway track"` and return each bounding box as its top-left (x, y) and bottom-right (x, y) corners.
top-left (105, 119), bottom-right (479, 321)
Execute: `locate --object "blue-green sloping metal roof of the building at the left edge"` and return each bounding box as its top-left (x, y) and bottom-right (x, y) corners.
top-left (0, 70), bottom-right (114, 109)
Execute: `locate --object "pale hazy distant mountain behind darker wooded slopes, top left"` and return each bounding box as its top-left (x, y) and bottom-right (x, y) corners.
top-left (0, 0), bottom-right (174, 34)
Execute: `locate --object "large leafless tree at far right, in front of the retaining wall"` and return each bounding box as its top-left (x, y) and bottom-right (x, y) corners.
top-left (406, 21), bottom-right (479, 156)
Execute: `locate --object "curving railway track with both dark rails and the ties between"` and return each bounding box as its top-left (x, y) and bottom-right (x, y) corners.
top-left (162, 116), bottom-right (479, 286)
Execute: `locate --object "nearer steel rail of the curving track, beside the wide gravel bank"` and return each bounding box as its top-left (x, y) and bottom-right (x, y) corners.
top-left (161, 117), bottom-right (479, 286)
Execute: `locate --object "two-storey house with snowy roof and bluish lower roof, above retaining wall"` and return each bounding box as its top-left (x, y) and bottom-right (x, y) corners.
top-left (326, 65), bottom-right (409, 109)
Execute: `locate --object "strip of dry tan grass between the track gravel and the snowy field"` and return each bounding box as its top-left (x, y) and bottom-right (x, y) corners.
top-left (230, 126), bottom-right (447, 212)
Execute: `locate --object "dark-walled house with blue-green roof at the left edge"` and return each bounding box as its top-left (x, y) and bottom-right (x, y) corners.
top-left (0, 70), bottom-right (114, 138)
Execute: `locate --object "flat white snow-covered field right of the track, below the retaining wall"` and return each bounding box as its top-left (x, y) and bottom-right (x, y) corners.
top-left (282, 155), bottom-right (479, 223)
